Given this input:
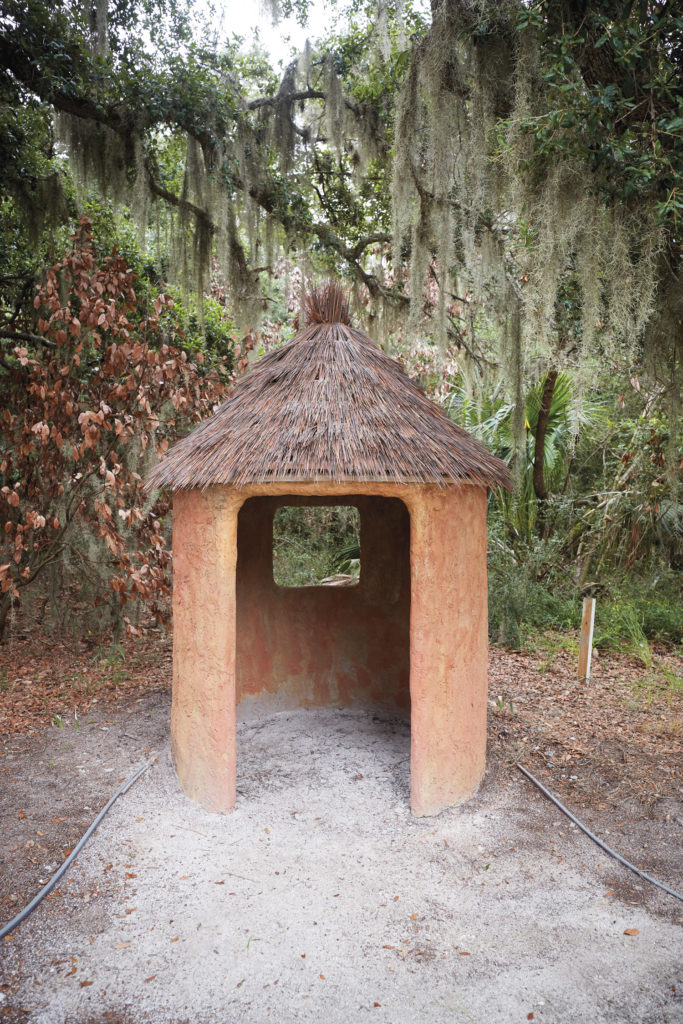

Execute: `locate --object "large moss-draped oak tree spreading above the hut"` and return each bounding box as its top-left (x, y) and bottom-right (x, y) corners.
top-left (0, 0), bottom-right (683, 376)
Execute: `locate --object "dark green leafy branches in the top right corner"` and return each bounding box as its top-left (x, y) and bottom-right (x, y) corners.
top-left (518, 2), bottom-right (683, 224)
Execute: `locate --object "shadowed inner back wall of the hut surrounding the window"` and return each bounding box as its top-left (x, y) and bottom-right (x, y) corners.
top-left (236, 495), bottom-right (411, 709)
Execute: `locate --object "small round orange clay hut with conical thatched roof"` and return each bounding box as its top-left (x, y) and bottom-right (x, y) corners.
top-left (147, 285), bottom-right (509, 815)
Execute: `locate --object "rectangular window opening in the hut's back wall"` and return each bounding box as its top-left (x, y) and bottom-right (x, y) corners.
top-left (272, 505), bottom-right (360, 587)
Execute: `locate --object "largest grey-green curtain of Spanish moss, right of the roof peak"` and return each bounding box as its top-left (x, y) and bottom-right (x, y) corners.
top-left (391, 3), bottom-right (663, 437)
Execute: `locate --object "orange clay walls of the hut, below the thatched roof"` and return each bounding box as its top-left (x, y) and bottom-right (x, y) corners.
top-left (171, 483), bottom-right (487, 815)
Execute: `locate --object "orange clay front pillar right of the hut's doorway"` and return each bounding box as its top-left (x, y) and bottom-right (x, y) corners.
top-left (405, 485), bottom-right (488, 816)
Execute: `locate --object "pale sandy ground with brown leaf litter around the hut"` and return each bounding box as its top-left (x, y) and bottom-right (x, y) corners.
top-left (0, 636), bottom-right (683, 1024)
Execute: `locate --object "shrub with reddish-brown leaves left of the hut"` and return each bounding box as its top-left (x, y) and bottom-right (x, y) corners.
top-left (0, 219), bottom-right (227, 636)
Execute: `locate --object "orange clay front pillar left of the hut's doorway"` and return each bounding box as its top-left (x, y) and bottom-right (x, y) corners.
top-left (171, 487), bottom-right (243, 812)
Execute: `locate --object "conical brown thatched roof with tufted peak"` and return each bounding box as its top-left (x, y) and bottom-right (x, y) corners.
top-left (147, 285), bottom-right (510, 490)
